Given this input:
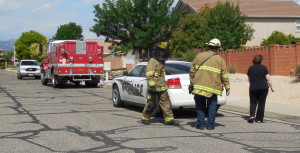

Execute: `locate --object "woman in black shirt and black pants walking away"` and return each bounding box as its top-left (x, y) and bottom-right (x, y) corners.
top-left (247, 55), bottom-right (274, 123)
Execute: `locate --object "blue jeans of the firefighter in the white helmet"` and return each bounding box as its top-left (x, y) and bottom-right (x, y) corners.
top-left (194, 94), bottom-right (218, 128)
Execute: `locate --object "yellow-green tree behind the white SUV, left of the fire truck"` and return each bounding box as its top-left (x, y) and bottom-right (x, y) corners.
top-left (14, 30), bottom-right (47, 60)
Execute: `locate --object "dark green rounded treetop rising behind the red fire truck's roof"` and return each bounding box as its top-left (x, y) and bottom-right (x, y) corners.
top-left (52, 22), bottom-right (83, 40)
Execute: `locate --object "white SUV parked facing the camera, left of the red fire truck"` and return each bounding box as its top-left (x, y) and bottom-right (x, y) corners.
top-left (17, 60), bottom-right (41, 79)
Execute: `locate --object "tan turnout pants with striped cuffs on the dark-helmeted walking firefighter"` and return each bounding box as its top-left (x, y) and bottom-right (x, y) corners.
top-left (142, 91), bottom-right (174, 122)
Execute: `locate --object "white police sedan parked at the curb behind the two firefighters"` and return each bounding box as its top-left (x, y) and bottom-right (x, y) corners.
top-left (112, 61), bottom-right (227, 114)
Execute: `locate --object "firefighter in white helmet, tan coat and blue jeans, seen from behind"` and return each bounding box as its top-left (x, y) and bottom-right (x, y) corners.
top-left (189, 39), bottom-right (230, 130)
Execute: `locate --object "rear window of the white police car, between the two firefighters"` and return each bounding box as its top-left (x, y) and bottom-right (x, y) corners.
top-left (165, 62), bottom-right (191, 75)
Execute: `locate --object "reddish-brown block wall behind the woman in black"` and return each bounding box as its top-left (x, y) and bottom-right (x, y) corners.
top-left (194, 43), bottom-right (300, 76)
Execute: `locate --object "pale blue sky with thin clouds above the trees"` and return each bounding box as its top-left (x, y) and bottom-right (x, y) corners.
top-left (0, 0), bottom-right (300, 40)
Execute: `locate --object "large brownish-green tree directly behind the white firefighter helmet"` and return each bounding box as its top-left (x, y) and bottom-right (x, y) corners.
top-left (172, 1), bottom-right (254, 52)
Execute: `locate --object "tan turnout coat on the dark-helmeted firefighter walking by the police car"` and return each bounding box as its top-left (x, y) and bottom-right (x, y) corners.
top-left (146, 58), bottom-right (169, 91)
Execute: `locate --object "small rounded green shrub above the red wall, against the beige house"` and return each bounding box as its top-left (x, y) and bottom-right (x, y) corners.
top-left (261, 31), bottom-right (291, 46)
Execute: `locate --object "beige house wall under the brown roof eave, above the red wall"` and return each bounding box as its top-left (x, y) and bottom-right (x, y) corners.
top-left (246, 18), bottom-right (300, 47)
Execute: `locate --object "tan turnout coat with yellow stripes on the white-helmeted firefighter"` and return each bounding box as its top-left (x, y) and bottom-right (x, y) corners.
top-left (190, 51), bottom-right (230, 97)
